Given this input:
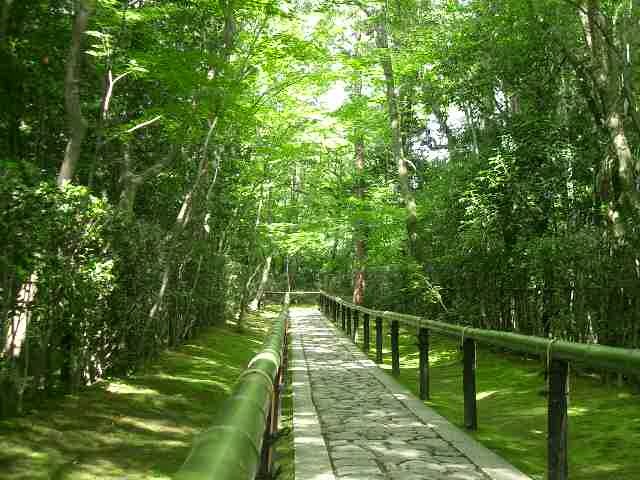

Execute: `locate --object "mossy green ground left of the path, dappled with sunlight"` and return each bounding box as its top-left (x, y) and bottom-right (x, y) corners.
top-left (0, 307), bottom-right (287, 480)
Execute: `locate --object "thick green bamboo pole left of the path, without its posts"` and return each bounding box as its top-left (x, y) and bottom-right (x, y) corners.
top-left (174, 295), bottom-right (289, 480)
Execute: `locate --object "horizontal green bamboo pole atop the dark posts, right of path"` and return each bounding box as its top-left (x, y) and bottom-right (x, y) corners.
top-left (320, 291), bottom-right (640, 374)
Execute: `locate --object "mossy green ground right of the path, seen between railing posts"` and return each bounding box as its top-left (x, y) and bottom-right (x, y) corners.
top-left (359, 324), bottom-right (640, 480)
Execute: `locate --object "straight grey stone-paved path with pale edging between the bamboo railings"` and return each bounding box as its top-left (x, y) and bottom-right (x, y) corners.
top-left (291, 308), bottom-right (531, 480)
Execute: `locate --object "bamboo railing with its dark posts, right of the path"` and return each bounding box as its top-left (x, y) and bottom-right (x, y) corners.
top-left (319, 291), bottom-right (640, 480)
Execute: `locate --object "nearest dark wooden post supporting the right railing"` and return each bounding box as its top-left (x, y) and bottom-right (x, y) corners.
top-left (547, 360), bottom-right (569, 480)
